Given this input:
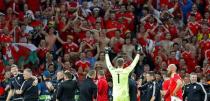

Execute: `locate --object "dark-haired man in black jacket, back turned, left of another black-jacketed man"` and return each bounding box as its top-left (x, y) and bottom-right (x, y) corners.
top-left (56, 71), bottom-right (78, 101)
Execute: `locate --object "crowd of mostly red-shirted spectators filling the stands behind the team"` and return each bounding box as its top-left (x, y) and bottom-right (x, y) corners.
top-left (0, 0), bottom-right (210, 100)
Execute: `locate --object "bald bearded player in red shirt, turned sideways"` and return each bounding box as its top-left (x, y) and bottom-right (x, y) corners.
top-left (166, 64), bottom-right (183, 100)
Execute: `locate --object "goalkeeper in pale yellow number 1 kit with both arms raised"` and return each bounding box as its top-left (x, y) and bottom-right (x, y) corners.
top-left (105, 47), bottom-right (141, 101)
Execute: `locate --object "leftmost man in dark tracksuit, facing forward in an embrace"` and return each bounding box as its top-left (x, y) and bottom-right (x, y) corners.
top-left (6, 65), bottom-right (24, 101)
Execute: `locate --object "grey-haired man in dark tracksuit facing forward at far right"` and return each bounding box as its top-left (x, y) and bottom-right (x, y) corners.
top-left (183, 73), bottom-right (207, 101)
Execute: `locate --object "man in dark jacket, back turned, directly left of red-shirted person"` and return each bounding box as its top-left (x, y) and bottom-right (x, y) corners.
top-left (79, 70), bottom-right (97, 101)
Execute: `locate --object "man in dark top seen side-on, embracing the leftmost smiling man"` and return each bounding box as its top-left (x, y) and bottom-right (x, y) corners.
top-left (16, 69), bottom-right (39, 101)
